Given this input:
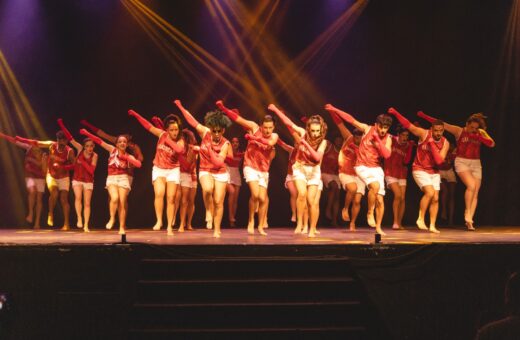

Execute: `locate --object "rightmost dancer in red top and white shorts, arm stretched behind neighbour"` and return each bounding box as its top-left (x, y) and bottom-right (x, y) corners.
top-left (417, 111), bottom-right (495, 230)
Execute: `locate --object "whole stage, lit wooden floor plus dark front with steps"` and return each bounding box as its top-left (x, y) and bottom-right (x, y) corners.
top-left (0, 227), bottom-right (520, 339)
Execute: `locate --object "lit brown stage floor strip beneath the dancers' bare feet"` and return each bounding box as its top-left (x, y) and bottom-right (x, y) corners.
top-left (0, 226), bottom-right (520, 246)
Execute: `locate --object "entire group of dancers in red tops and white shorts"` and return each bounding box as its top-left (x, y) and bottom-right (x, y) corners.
top-left (0, 100), bottom-right (495, 238)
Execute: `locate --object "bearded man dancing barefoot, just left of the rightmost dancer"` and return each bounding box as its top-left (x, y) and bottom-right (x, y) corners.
top-left (388, 107), bottom-right (450, 233)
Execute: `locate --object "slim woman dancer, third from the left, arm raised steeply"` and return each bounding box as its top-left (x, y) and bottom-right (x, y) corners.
top-left (58, 118), bottom-right (98, 233)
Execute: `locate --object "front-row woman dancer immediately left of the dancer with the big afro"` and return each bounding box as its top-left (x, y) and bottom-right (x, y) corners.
top-left (128, 110), bottom-right (184, 236)
